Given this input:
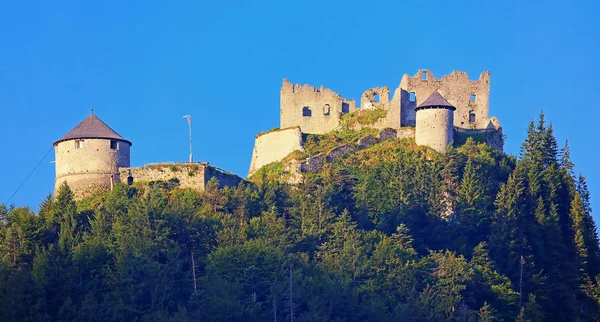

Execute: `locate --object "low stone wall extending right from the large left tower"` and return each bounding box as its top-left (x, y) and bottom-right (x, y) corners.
top-left (119, 163), bottom-right (243, 191)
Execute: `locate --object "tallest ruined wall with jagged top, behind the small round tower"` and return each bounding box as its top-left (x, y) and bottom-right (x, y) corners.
top-left (400, 69), bottom-right (490, 129)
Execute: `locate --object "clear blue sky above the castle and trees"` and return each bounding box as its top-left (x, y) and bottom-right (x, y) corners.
top-left (0, 1), bottom-right (600, 219)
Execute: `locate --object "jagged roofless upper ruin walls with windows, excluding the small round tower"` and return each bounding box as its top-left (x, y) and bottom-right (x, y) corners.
top-left (280, 69), bottom-right (500, 134)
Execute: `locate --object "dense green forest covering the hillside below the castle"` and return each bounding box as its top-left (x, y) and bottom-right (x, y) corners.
top-left (0, 114), bottom-right (600, 322)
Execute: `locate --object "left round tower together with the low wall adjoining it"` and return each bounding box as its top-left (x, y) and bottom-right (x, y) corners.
top-left (54, 114), bottom-right (242, 200)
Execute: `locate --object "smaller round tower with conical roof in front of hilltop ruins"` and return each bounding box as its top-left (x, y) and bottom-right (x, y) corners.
top-left (415, 91), bottom-right (456, 152)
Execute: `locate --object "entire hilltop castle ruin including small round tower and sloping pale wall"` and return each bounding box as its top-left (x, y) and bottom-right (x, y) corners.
top-left (248, 69), bottom-right (504, 175)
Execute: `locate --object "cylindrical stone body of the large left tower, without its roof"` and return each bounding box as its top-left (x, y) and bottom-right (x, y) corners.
top-left (54, 139), bottom-right (130, 200)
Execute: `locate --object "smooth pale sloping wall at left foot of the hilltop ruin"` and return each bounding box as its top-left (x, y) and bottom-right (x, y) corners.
top-left (248, 126), bottom-right (304, 176)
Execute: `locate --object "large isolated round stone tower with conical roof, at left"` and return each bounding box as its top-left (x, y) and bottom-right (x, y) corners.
top-left (54, 114), bottom-right (131, 200)
